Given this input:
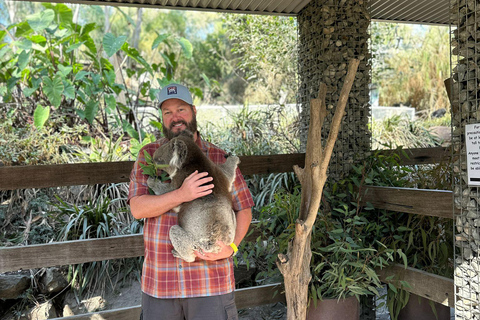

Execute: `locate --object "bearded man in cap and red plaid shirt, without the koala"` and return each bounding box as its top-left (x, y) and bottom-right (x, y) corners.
top-left (128, 84), bottom-right (253, 320)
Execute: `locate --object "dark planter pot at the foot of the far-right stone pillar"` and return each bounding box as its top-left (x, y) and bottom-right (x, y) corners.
top-left (398, 294), bottom-right (450, 320)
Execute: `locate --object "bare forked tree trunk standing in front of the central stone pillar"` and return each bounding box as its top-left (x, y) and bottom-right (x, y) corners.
top-left (277, 59), bottom-right (360, 320)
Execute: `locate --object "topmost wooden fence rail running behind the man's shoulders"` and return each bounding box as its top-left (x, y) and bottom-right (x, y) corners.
top-left (0, 147), bottom-right (451, 190)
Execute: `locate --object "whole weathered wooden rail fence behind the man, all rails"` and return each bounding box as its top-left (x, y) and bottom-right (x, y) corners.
top-left (0, 148), bottom-right (454, 320)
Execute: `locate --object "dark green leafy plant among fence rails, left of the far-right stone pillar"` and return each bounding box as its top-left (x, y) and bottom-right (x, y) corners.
top-left (344, 148), bottom-right (454, 320)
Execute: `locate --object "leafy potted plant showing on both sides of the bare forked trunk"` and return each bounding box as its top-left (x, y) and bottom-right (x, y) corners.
top-left (257, 172), bottom-right (403, 320)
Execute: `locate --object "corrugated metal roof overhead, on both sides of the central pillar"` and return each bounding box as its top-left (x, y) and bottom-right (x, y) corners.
top-left (29, 0), bottom-right (450, 25)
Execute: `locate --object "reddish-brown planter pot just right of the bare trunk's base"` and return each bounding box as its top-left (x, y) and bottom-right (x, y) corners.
top-left (307, 297), bottom-right (360, 320)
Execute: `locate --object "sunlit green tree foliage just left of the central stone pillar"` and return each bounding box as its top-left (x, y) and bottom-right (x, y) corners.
top-left (224, 14), bottom-right (297, 103)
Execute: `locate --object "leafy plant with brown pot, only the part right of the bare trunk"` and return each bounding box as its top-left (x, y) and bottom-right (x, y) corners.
top-left (308, 179), bottom-right (403, 320)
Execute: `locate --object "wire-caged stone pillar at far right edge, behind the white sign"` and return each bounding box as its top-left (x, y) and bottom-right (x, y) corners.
top-left (451, 0), bottom-right (480, 320)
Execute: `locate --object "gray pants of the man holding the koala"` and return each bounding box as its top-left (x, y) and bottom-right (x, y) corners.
top-left (141, 292), bottom-right (238, 320)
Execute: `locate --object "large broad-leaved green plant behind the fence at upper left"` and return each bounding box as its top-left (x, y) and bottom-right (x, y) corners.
top-left (0, 3), bottom-right (195, 141)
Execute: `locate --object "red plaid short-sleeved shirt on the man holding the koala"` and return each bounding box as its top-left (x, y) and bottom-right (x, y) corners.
top-left (128, 134), bottom-right (253, 299)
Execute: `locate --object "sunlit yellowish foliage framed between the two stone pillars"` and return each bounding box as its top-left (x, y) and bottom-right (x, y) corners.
top-left (371, 22), bottom-right (450, 112)
